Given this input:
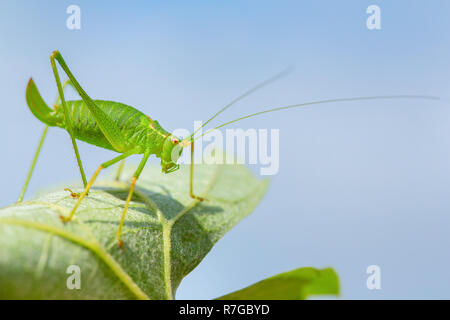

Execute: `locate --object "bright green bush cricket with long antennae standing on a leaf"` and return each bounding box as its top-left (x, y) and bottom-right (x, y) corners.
top-left (18, 51), bottom-right (438, 248)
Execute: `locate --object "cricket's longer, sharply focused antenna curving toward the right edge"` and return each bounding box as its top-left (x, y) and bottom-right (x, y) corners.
top-left (194, 95), bottom-right (439, 141)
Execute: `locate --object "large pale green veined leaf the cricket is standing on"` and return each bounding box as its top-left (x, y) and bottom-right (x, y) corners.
top-left (0, 165), bottom-right (268, 299)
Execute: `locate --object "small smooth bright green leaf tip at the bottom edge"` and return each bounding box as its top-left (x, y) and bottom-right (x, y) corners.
top-left (218, 267), bottom-right (339, 300)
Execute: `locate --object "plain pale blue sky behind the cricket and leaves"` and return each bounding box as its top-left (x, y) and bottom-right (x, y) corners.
top-left (0, 0), bottom-right (450, 299)
